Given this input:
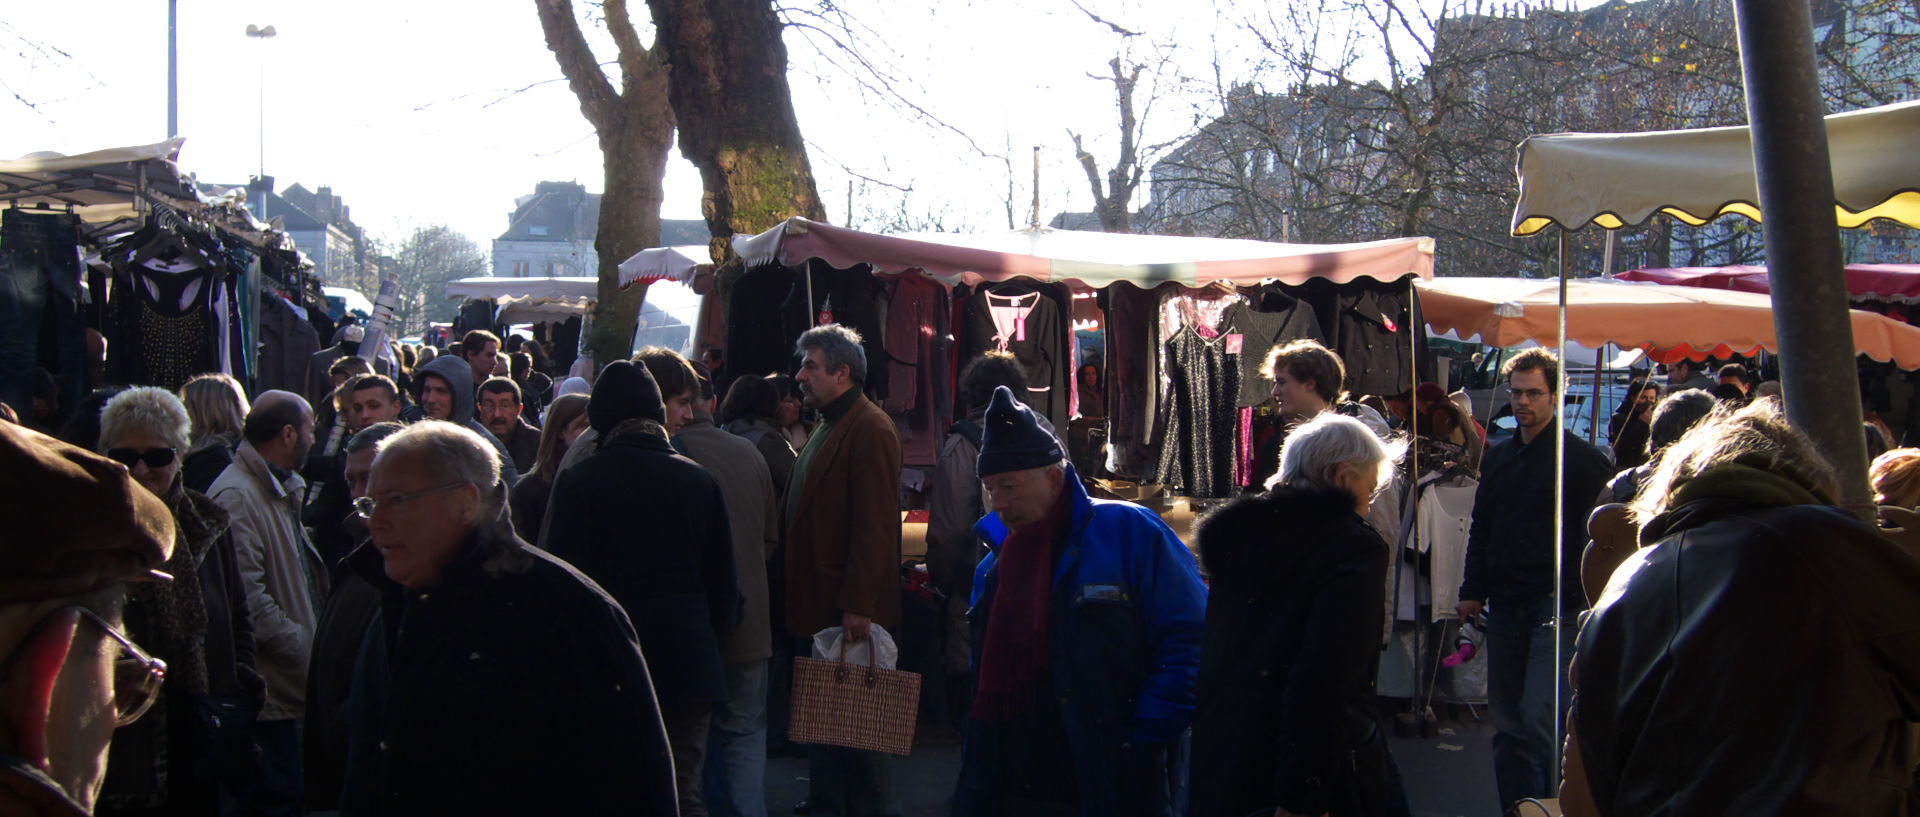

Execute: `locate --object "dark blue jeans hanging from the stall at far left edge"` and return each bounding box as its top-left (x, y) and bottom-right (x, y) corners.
top-left (0, 209), bottom-right (86, 422)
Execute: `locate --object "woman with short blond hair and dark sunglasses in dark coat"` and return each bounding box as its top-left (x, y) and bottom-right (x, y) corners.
top-left (98, 387), bottom-right (265, 813)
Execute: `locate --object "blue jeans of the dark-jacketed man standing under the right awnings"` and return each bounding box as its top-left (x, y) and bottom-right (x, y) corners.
top-left (1486, 598), bottom-right (1576, 809)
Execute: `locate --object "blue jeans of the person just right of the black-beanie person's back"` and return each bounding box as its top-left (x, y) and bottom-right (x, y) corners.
top-left (707, 660), bottom-right (768, 817)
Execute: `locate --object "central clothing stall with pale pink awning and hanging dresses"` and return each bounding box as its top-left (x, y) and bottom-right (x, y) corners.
top-left (683, 219), bottom-right (1432, 485)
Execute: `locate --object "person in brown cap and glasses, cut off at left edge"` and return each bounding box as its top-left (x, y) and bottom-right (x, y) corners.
top-left (0, 422), bottom-right (175, 815)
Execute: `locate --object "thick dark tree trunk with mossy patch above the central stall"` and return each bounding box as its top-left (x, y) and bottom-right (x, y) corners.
top-left (647, 0), bottom-right (826, 258)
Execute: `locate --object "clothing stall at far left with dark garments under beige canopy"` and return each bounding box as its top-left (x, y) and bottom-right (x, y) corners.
top-left (0, 138), bottom-right (332, 421)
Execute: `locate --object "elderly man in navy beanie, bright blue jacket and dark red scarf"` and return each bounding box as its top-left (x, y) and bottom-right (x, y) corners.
top-left (954, 387), bottom-right (1206, 817)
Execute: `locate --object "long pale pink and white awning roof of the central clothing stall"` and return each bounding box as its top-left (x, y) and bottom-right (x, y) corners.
top-left (718, 219), bottom-right (1434, 288)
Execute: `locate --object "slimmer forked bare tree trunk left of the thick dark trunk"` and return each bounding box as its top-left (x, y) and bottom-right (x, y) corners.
top-left (534, 0), bottom-right (674, 364)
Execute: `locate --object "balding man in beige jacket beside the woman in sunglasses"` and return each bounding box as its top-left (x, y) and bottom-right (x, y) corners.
top-left (207, 391), bottom-right (326, 815)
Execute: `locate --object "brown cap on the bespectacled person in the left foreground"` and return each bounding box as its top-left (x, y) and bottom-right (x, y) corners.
top-left (0, 422), bottom-right (173, 604)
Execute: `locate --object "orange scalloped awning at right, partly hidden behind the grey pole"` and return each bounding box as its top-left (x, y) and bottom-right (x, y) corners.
top-left (1419, 278), bottom-right (1920, 368)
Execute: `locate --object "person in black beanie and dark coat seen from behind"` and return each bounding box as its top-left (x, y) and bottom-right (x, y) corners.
top-left (541, 361), bottom-right (741, 815)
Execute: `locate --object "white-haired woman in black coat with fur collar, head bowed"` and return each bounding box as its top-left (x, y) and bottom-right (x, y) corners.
top-left (1190, 412), bottom-right (1407, 817)
